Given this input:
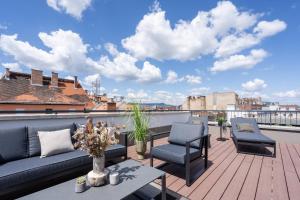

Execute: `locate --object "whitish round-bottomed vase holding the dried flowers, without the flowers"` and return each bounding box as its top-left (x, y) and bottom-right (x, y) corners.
top-left (87, 156), bottom-right (108, 187)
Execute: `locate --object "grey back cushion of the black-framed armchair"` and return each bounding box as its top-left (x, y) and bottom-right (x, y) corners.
top-left (168, 123), bottom-right (205, 148)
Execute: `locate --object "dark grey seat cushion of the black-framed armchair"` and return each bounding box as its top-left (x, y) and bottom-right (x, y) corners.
top-left (151, 144), bottom-right (201, 164)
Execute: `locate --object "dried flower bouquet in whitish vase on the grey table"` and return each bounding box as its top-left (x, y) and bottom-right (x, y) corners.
top-left (73, 118), bottom-right (121, 186)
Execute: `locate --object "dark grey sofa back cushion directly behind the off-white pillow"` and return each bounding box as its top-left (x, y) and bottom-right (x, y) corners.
top-left (28, 124), bottom-right (76, 157)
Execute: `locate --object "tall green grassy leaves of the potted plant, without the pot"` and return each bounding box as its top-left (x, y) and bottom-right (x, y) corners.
top-left (129, 104), bottom-right (149, 142)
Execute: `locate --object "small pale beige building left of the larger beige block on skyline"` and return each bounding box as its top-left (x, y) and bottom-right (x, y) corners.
top-left (182, 96), bottom-right (206, 110)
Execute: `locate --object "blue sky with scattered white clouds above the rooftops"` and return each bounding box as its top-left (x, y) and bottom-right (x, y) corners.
top-left (0, 0), bottom-right (300, 104)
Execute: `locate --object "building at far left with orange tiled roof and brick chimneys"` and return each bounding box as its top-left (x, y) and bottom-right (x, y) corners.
top-left (0, 68), bottom-right (94, 111)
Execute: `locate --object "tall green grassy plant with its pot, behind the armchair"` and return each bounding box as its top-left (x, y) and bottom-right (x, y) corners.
top-left (129, 104), bottom-right (149, 160)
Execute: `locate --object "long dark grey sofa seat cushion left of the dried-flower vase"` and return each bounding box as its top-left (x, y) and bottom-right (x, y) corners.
top-left (0, 150), bottom-right (92, 192)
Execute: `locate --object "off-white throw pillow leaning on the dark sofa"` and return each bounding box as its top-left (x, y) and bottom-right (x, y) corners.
top-left (38, 129), bottom-right (74, 158)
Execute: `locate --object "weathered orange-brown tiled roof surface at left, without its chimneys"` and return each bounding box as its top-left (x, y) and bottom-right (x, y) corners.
top-left (0, 72), bottom-right (92, 107)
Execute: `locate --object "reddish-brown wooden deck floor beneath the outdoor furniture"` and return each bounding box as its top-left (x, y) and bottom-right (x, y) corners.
top-left (129, 129), bottom-right (300, 200)
